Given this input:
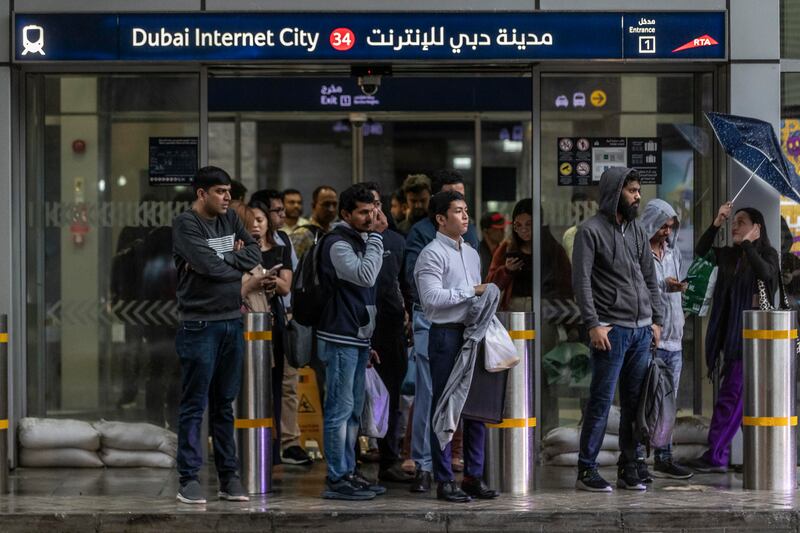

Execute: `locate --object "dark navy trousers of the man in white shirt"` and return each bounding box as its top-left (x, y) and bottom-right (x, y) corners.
top-left (429, 326), bottom-right (486, 483)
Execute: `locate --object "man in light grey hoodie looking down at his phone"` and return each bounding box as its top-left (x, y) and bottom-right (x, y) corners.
top-left (642, 198), bottom-right (692, 479)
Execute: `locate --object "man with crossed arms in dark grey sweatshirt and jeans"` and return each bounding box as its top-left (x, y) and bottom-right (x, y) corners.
top-left (172, 166), bottom-right (261, 504)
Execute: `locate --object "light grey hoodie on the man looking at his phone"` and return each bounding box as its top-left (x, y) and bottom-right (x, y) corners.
top-left (642, 198), bottom-right (685, 352)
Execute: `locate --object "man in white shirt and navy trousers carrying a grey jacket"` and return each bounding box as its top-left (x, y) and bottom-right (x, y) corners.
top-left (414, 191), bottom-right (498, 503)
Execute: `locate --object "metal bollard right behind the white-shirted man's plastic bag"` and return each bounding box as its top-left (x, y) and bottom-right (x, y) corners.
top-left (485, 312), bottom-right (536, 494)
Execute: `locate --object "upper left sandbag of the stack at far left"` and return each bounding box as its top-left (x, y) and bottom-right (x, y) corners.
top-left (18, 418), bottom-right (100, 448)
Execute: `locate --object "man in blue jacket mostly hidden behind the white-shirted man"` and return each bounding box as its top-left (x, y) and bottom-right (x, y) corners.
top-left (403, 170), bottom-right (478, 492)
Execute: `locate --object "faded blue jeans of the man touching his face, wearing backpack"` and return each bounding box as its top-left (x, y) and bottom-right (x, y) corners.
top-left (317, 339), bottom-right (369, 481)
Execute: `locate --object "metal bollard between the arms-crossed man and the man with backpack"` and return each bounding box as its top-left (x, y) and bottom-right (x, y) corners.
top-left (234, 313), bottom-right (275, 494)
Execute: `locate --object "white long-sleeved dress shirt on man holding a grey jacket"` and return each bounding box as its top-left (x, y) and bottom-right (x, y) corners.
top-left (414, 231), bottom-right (481, 324)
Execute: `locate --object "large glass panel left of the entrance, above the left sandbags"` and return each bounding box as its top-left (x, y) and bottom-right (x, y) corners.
top-left (26, 74), bottom-right (200, 427)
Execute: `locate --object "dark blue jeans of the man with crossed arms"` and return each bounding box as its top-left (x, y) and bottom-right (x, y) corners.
top-left (175, 318), bottom-right (244, 485)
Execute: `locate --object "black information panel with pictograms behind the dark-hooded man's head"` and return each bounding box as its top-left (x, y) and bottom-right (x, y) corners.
top-left (557, 137), bottom-right (661, 187)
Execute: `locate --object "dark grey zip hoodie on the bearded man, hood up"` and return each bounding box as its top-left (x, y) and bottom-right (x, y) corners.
top-left (572, 167), bottom-right (664, 329)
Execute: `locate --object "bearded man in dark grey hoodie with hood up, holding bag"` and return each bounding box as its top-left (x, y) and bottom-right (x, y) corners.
top-left (572, 167), bottom-right (663, 492)
